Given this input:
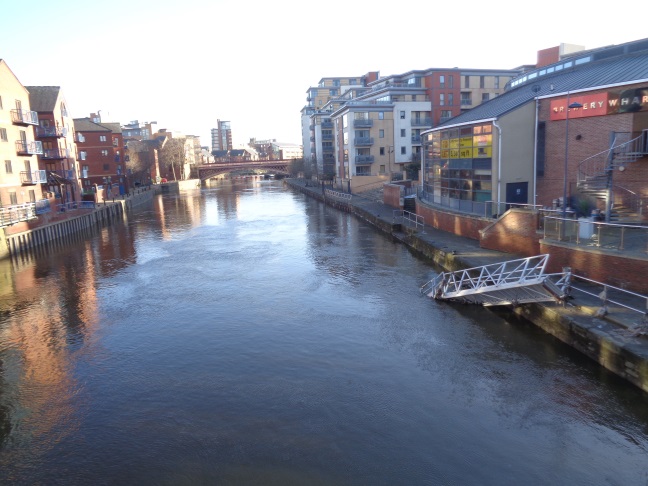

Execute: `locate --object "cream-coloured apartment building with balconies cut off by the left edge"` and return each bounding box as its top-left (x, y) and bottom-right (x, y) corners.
top-left (0, 59), bottom-right (47, 208)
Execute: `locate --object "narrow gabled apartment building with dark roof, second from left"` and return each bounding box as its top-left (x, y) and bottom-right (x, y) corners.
top-left (27, 86), bottom-right (81, 203)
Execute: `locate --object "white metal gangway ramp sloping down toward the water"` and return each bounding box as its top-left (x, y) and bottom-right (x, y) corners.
top-left (421, 255), bottom-right (571, 306)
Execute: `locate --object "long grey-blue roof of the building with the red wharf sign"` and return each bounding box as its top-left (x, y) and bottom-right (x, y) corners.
top-left (424, 38), bottom-right (648, 133)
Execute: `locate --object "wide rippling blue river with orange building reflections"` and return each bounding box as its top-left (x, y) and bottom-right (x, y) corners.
top-left (0, 180), bottom-right (648, 486)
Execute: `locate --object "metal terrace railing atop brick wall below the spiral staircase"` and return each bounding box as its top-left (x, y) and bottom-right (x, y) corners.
top-left (542, 216), bottom-right (648, 253)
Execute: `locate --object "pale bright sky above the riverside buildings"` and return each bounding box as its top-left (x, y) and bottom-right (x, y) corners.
top-left (0, 0), bottom-right (648, 146)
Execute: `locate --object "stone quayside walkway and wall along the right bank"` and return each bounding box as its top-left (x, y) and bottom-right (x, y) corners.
top-left (286, 179), bottom-right (648, 392)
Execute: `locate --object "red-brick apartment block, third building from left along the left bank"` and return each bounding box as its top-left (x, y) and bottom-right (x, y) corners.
top-left (74, 113), bottom-right (128, 197)
